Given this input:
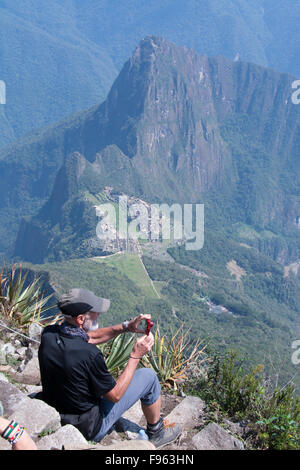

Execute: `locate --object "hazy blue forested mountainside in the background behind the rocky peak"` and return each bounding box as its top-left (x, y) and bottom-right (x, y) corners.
top-left (0, 0), bottom-right (300, 147)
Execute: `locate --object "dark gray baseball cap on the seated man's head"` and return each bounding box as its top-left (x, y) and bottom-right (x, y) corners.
top-left (57, 288), bottom-right (110, 317)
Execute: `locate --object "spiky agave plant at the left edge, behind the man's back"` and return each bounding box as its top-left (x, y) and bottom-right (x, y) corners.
top-left (0, 265), bottom-right (56, 327)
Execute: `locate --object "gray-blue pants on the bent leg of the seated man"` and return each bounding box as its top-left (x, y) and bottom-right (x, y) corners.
top-left (93, 368), bottom-right (161, 442)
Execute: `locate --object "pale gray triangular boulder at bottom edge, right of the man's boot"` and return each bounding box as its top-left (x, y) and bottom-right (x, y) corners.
top-left (192, 423), bottom-right (244, 450)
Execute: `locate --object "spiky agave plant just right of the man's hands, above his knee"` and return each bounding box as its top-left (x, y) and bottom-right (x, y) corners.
top-left (142, 325), bottom-right (205, 390)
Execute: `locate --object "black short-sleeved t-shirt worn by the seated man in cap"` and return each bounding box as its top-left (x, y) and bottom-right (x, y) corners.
top-left (39, 325), bottom-right (116, 438)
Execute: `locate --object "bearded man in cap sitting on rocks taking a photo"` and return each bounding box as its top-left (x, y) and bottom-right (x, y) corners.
top-left (39, 289), bottom-right (180, 448)
